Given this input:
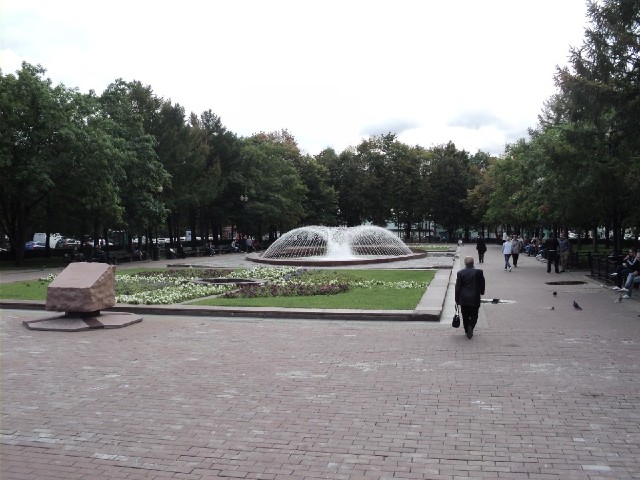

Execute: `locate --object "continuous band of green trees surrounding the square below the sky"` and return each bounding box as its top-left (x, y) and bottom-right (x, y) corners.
top-left (0, 0), bottom-right (640, 263)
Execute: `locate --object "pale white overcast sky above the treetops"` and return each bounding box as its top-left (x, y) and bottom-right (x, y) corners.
top-left (0, 0), bottom-right (587, 155)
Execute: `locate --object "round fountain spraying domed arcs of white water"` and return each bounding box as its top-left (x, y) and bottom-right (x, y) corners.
top-left (249, 225), bottom-right (425, 266)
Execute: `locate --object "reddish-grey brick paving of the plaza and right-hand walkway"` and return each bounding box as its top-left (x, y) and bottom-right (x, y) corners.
top-left (0, 245), bottom-right (640, 480)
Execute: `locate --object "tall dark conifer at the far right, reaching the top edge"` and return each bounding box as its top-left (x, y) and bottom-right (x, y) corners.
top-left (552, 0), bottom-right (640, 250)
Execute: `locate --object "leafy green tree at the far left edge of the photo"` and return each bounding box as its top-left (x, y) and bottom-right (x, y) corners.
top-left (0, 63), bottom-right (79, 265)
